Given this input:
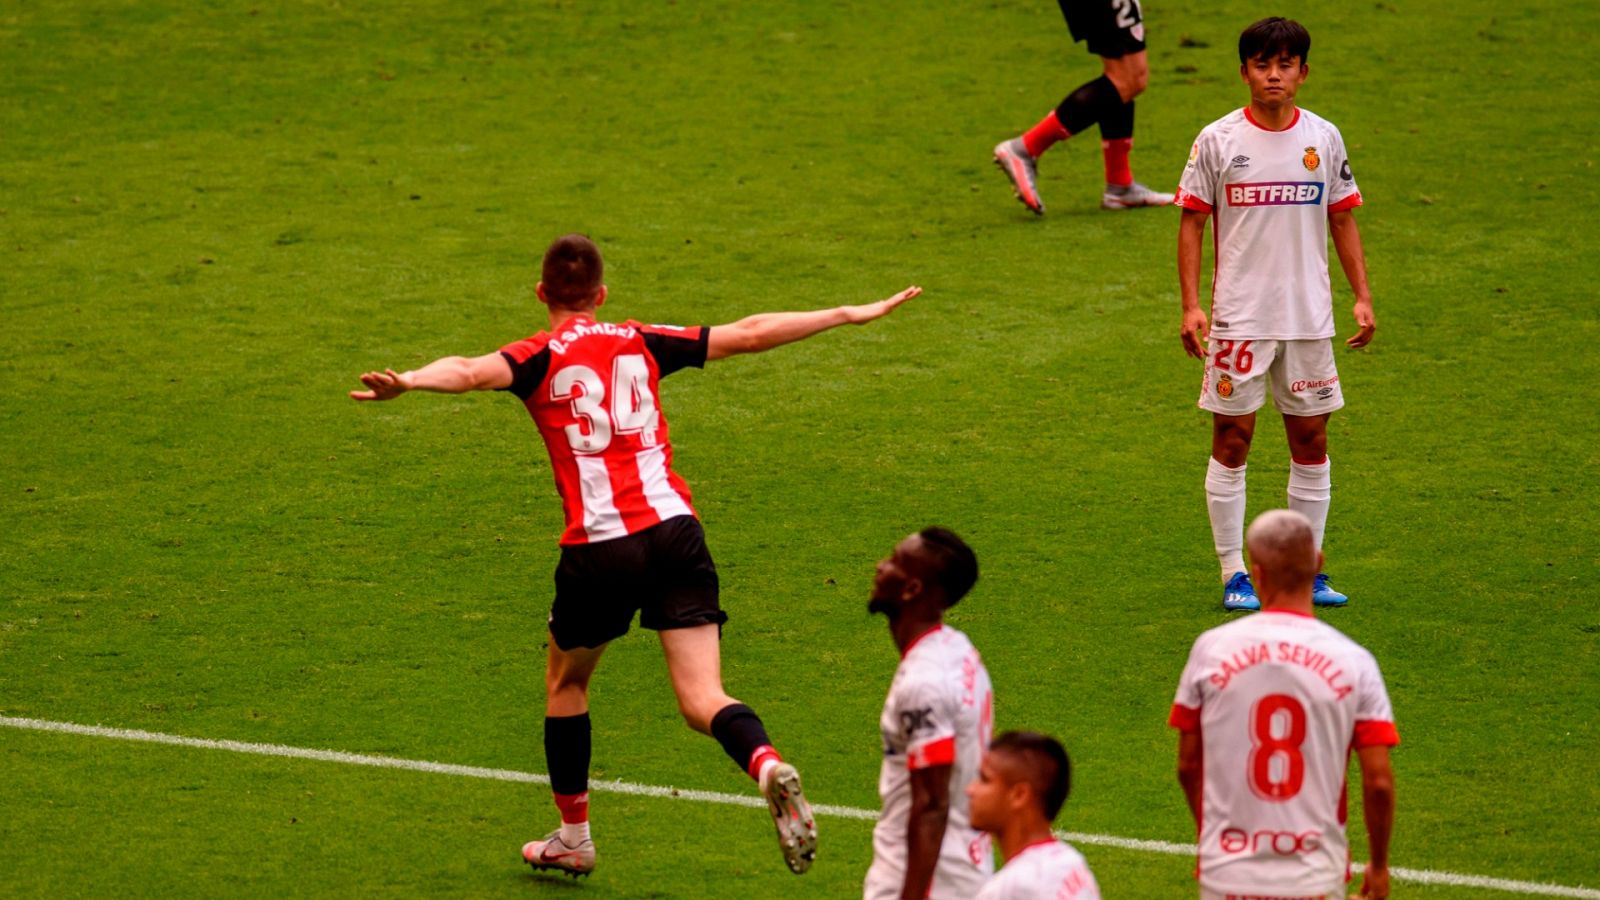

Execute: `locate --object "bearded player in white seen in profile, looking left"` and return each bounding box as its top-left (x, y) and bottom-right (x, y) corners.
top-left (864, 528), bottom-right (994, 900)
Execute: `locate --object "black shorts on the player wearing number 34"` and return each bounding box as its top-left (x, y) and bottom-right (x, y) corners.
top-left (550, 516), bottom-right (728, 650)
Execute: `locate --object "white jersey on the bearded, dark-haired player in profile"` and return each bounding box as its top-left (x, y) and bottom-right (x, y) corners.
top-left (866, 625), bottom-right (995, 900)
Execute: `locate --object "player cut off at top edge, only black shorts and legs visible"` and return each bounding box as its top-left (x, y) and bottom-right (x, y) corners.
top-left (995, 0), bottom-right (1173, 216)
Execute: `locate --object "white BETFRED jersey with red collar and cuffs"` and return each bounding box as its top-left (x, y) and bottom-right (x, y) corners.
top-left (1174, 109), bottom-right (1362, 341)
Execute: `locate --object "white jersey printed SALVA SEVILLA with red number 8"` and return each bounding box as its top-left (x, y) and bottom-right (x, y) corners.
top-left (1170, 610), bottom-right (1400, 897)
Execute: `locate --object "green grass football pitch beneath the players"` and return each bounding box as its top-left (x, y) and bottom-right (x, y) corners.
top-left (0, 0), bottom-right (1600, 898)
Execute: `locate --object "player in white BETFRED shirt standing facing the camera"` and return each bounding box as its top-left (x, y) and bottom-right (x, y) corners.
top-left (1178, 18), bottom-right (1376, 610)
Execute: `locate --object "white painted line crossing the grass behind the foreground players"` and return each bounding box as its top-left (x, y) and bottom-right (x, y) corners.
top-left (9, 716), bottom-right (1600, 900)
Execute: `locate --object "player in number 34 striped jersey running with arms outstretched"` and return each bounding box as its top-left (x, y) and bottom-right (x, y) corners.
top-left (350, 234), bottom-right (922, 876)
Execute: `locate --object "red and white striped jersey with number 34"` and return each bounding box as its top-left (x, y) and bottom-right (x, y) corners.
top-left (499, 315), bottom-right (710, 544)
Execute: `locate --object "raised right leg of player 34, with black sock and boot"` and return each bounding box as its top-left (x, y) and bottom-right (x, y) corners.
top-left (661, 625), bottom-right (816, 874)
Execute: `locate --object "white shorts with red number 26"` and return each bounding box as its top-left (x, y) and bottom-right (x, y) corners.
top-left (1200, 338), bottom-right (1344, 416)
